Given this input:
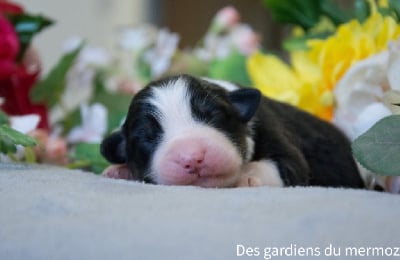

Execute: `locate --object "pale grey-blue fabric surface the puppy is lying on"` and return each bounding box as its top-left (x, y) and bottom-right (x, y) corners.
top-left (0, 164), bottom-right (400, 259)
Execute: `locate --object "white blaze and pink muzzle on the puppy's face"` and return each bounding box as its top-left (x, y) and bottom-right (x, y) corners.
top-left (150, 78), bottom-right (243, 187)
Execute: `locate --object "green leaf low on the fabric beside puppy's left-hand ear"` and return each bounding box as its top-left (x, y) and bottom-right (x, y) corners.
top-left (71, 143), bottom-right (109, 174)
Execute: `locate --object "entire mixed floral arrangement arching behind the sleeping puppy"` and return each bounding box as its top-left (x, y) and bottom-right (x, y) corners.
top-left (0, 0), bottom-right (400, 187)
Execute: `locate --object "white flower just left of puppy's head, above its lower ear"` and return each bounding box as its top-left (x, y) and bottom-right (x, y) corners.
top-left (67, 103), bottom-right (107, 143)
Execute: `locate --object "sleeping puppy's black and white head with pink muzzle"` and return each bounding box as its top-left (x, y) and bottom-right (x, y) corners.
top-left (101, 75), bottom-right (261, 187)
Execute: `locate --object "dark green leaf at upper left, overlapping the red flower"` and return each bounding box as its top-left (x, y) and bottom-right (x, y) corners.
top-left (9, 14), bottom-right (53, 60)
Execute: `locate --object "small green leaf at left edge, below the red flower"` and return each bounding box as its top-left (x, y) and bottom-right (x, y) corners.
top-left (0, 124), bottom-right (36, 154)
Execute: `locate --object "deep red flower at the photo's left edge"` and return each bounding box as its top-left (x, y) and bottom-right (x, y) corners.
top-left (0, 1), bottom-right (49, 129)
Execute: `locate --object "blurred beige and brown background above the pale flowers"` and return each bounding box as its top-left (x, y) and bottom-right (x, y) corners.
top-left (18, 0), bottom-right (285, 72)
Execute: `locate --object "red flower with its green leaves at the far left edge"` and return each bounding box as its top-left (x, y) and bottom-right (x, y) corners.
top-left (0, 1), bottom-right (52, 156)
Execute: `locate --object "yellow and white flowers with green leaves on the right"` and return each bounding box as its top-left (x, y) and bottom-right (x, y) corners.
top-left (253, 0), bottom-right (400, 185)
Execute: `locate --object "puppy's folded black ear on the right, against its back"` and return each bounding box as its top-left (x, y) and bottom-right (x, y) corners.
top-left (229, 88), bottom-right (261, 123)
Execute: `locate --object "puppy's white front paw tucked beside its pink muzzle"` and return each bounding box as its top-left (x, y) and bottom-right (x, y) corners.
top-left (237, 160), bottom-right (284, 187)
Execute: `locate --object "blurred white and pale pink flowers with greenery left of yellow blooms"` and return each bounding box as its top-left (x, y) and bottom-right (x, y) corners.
top-left (0, 2), bottom-right (260, 173)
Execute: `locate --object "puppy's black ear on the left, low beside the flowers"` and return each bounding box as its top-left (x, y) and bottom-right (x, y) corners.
top-left (100, 131), bottom-right (126, 164)
